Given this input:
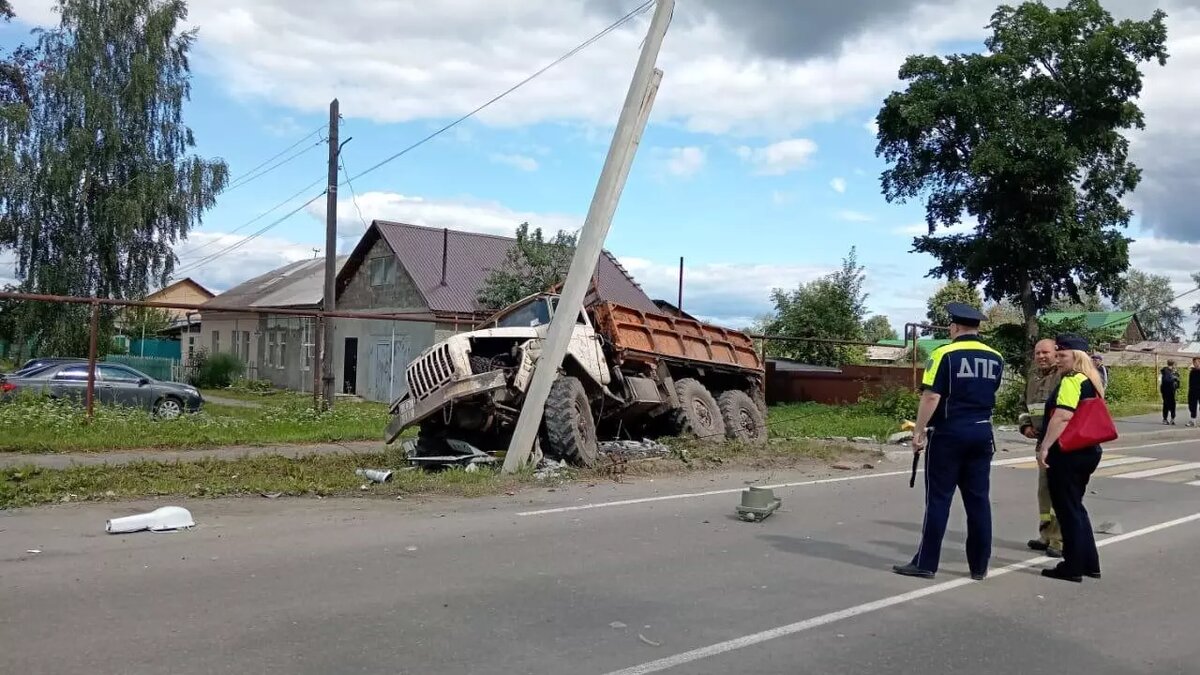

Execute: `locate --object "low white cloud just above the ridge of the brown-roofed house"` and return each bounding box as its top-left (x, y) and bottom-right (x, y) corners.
top-left (308, 192), bottom-right (583, 241)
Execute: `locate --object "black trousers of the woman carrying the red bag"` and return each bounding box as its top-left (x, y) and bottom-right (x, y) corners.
top-left (1046, 448), bottom-right (1100, 575)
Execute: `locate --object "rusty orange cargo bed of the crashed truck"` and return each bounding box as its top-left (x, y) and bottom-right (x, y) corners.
top-left (592, 303), bottom-right (763, 372)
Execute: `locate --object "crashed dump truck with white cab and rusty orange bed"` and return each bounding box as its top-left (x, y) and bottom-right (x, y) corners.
top-left (386, 293), bottom-right (767, 466)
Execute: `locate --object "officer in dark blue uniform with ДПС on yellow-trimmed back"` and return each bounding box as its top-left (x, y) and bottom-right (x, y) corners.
top-left (892, 303), bottom-right (1004, 580)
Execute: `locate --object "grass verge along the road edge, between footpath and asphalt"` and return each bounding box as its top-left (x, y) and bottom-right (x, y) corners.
top-left (0, 432), bottom-right (862, 508)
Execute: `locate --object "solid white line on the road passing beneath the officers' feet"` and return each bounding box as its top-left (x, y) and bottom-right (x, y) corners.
top-left (606, 509), bottom-right (1200, 675)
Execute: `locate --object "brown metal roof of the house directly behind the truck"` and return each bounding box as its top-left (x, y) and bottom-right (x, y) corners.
top-left (338, 220), bottom-right (658, 313)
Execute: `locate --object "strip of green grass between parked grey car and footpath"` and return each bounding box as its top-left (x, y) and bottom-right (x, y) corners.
top-left (0, 399), bottom-right (388, 453)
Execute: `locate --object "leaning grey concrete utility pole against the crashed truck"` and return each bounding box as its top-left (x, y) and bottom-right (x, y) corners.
top-left (504, 0), bottom-right (674, 473)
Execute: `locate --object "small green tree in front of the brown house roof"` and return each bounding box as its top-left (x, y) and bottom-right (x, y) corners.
top-left (479, 222), bottom-right (576, 310)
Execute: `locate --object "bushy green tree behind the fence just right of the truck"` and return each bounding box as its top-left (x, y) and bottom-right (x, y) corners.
top-left (767, 249), bottom-right (866, 366)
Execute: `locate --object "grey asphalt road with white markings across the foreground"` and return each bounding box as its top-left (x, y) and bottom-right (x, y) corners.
top-left (0, 430), bottom-right (1200, 675)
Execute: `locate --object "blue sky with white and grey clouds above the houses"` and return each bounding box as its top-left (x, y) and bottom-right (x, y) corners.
top-left (0, 0), bottom-right (1200, 328)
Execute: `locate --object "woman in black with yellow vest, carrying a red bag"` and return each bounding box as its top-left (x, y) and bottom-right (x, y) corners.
top-left (1038, 335), bottom-right (1104, 584)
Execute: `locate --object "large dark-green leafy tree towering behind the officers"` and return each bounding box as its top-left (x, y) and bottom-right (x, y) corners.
top-left (876, 0), bottom-right (1168, 339)
